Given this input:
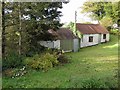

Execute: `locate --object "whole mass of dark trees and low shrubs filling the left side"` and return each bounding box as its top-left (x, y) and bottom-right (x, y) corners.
top-left (2, 2), bottom-right (70, 76)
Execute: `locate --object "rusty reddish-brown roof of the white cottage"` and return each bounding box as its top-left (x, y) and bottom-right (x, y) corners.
top-left (76, 23), bottom-right (109, 34)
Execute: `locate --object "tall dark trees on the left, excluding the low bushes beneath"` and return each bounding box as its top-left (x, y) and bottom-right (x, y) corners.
top-left (4, 2), bottom-right (62, 53)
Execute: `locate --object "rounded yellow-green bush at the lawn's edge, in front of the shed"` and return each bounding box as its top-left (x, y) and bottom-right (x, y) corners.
top-left (24, 53), bottom-right (58, 70)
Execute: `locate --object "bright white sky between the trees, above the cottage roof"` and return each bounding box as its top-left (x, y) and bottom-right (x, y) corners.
top-left (60, 0), bottom-right (97, 23)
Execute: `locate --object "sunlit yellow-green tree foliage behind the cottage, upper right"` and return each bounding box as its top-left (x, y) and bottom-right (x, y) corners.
top-left (81, 2), bottom-right (120, 26)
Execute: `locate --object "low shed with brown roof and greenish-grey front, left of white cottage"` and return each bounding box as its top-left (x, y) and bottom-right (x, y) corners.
top-left (39, 28), bottom-right (79, 52)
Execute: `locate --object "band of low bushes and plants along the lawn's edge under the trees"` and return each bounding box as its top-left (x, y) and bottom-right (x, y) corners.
top-left (2, 48), bottom-right (70, 77)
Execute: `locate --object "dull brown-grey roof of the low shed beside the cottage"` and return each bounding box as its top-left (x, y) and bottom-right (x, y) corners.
top-left (48, 28), bottom-right (77, 39)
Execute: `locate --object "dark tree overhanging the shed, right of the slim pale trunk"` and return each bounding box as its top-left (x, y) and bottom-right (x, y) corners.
top-left (21, 2), bottom-right (62, 50)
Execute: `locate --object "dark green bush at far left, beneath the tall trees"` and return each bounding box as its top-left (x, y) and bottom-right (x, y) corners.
top-left (2, 52), bottom-right (23, 70)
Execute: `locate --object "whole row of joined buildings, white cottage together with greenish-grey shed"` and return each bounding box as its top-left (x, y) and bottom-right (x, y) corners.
top-left (39, 23), bottom-right (109, 52)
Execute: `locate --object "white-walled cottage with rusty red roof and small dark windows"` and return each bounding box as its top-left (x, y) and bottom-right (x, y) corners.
top-left (76, 23), bottom-right (109, 48)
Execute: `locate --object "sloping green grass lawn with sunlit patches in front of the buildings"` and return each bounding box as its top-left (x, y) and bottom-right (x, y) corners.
top-left (2, 35), bottom-right (118, 88)
